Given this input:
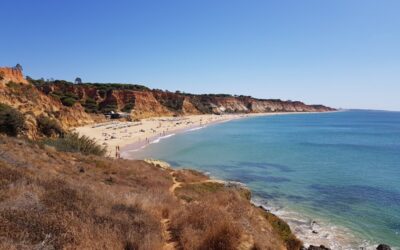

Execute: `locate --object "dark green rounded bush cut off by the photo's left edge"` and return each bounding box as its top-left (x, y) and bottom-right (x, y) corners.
top-left (0, 103), bottom-right (25, 136)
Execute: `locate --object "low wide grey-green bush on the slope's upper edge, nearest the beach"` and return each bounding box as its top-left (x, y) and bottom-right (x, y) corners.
top-left (44, 133), bottom-right (107, 156)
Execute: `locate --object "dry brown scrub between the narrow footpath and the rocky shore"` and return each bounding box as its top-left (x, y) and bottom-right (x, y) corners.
top-left (171, 173), bottom-right (301, 250)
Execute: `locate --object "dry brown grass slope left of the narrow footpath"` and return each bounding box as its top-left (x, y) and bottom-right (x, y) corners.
top-left (0, 137), bottom-right (170, 250)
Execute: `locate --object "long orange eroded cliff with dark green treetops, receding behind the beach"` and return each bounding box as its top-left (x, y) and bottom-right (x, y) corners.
top-left (39, 82), bottom-right (334, 119)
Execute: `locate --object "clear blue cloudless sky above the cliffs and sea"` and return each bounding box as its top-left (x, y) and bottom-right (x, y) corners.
top-left (0, 0), bottom-right (400, 110)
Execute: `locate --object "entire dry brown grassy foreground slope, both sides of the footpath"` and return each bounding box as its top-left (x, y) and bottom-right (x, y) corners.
top-left (0, 136), bottom-right (298, 250)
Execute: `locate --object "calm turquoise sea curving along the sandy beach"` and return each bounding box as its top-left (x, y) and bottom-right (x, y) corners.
top-left (126, 111), bottom-right (400, 248)
